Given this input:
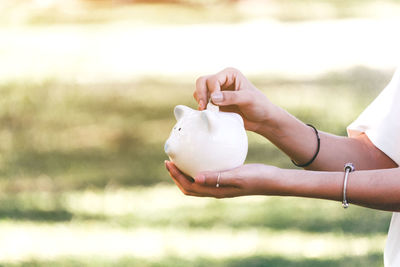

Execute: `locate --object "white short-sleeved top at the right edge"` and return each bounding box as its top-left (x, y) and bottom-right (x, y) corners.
top-left (347, 68), bottom-right (400, 267)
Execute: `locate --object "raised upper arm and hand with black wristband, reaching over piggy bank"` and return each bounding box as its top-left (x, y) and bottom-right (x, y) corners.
top-left (194, 68), bottom-right (397, 171)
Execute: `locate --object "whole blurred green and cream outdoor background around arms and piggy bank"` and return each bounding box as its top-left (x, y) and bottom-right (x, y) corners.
top-left (0, 0), bottom-right (400, 266)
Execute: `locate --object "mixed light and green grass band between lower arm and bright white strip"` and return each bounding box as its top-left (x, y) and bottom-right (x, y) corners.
top-left (0, 185), bottom-right (390, 235)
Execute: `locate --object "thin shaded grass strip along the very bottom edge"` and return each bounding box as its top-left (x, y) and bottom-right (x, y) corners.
top-left (0, 254), bottom-right (383, 267)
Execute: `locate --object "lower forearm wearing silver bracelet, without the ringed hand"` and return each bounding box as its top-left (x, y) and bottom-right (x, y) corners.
top-left (272, 168), bottom-right (400, 212)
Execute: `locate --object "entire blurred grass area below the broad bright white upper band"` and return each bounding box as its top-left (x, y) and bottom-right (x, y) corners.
top-left (0, 68), bottom-right (390, 266)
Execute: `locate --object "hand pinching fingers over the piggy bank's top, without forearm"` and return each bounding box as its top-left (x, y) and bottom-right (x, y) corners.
top-left (193, 68), bottom-right (277, 132)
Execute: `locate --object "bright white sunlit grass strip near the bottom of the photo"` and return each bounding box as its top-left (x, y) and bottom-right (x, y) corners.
top-left (0, 223), bottom-right (385, 262)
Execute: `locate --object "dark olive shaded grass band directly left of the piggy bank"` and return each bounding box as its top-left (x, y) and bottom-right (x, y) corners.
top-left (0, 142), bottom-right (169, 192)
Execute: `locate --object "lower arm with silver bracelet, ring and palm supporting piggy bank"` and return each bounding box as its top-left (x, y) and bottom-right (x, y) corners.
top-left (166, 162), bottom-right (400, 212)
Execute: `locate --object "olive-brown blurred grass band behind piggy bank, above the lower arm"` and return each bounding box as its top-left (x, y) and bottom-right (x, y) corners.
top-left (0, 68), bottom-right (389, 191)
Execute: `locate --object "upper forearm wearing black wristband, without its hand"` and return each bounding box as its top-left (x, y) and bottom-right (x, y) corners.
top-left (256, 107), bottom-right (397, 171)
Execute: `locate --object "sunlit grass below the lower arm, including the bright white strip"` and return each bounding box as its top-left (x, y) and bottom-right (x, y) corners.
top-left (0, 186), bottom-right (389, 264)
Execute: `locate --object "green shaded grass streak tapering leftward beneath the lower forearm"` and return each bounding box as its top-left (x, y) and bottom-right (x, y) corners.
top-left (136, 197), bottom-right (392, 235)
